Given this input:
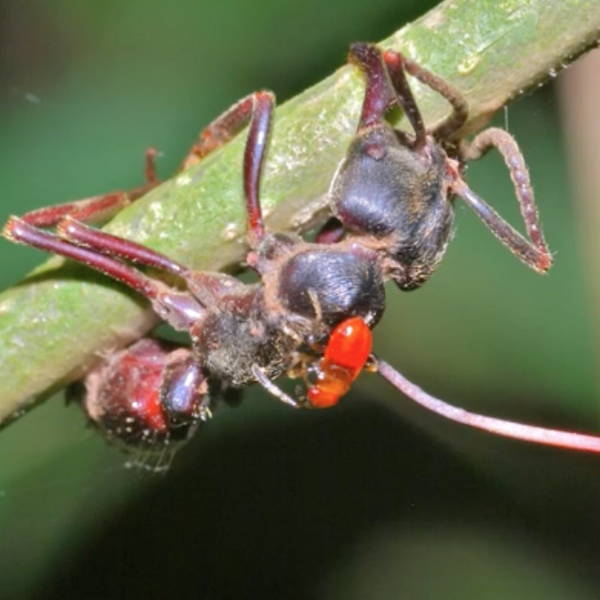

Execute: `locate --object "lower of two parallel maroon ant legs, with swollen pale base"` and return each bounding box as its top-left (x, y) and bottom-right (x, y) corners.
top-left (2, 217), bottom-right (204, 331)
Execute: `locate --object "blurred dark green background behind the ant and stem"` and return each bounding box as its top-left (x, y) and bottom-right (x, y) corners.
top-left (0, 0), bottom-right (600, 600)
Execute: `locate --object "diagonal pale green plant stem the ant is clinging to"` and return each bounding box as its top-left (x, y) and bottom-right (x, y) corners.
top-left (0, 0), bottom-right (600, 425)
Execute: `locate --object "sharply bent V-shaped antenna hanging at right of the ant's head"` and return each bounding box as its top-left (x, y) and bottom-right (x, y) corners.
top-left (451, 128), bottom-right (552, 273)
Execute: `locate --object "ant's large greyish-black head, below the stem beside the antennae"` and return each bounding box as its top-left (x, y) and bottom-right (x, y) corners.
top-left (330, 123), bottom-right (454, 290)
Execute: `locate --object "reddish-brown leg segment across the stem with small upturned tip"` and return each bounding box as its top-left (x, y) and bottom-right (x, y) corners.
top-left (22, 148), bottom-right (159, 228)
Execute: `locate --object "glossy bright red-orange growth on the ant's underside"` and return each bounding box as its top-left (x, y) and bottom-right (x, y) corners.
top-left (307, 317), bottom-right (373, 408)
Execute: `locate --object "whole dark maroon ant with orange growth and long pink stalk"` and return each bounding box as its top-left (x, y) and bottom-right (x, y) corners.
top-left (4, 43), bottom-right (600, 462)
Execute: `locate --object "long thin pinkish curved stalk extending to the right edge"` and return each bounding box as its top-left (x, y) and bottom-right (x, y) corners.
top-left (375, 358), bottom-right (600, 453)
